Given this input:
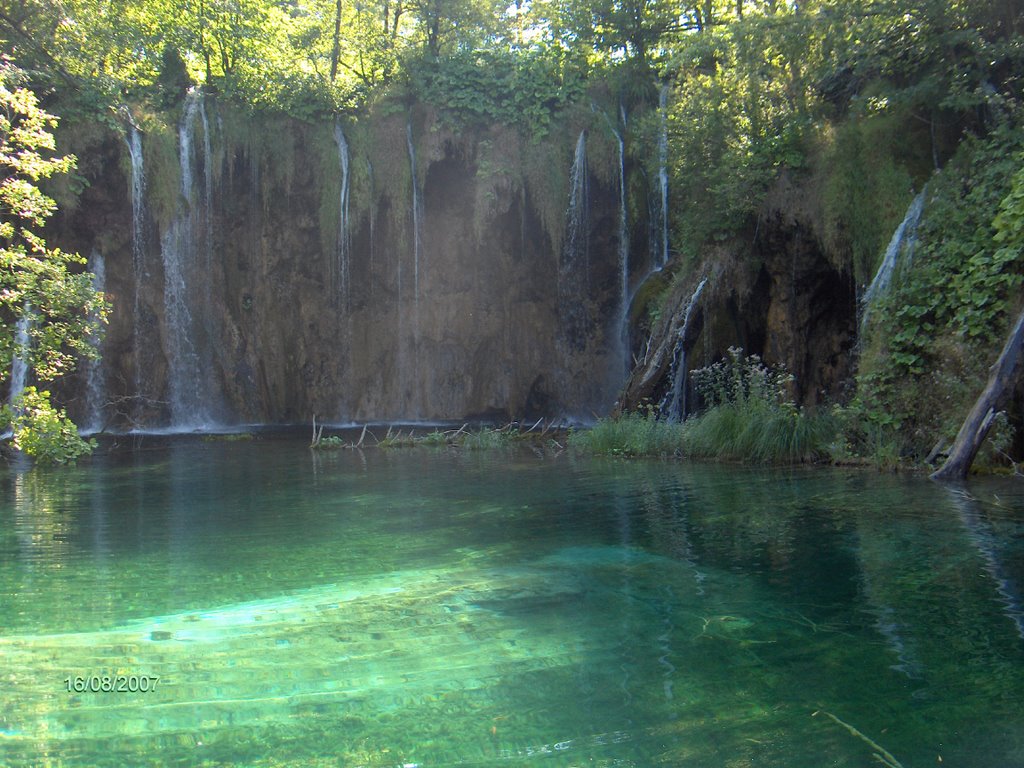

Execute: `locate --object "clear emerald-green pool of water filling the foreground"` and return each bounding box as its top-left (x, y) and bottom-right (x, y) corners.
top-left (0, 438), bottom-right (1024, 768)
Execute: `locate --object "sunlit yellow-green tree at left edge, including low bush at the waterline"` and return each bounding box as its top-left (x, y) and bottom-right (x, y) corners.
top-left (0, 60), bottom-right (106, 461)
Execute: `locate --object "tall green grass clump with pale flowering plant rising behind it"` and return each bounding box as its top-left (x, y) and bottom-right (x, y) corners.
top-left (683, 348), bottom-right (837, 464)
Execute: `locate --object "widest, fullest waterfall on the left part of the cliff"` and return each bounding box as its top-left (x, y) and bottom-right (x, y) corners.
top-left (161, 88), bottom-right (215, 428)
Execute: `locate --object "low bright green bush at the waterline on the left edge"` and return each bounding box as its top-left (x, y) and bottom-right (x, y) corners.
top-left (0, 387), bottom-right (96, 464)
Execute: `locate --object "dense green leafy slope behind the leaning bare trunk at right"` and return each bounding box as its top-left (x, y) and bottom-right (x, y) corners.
top-left (852, 119), bottom-right (1024, 457)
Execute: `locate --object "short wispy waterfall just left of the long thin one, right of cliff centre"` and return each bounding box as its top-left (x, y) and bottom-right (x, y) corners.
top-left (558, 131), bottom-right (590, 350)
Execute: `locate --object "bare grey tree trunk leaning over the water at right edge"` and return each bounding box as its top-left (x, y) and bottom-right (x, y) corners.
top-left (932, 311), bottom-right (1024, 480)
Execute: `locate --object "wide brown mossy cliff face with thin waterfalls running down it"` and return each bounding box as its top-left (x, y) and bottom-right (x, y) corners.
top-left (49, 98), bottom-right (622, 428)
